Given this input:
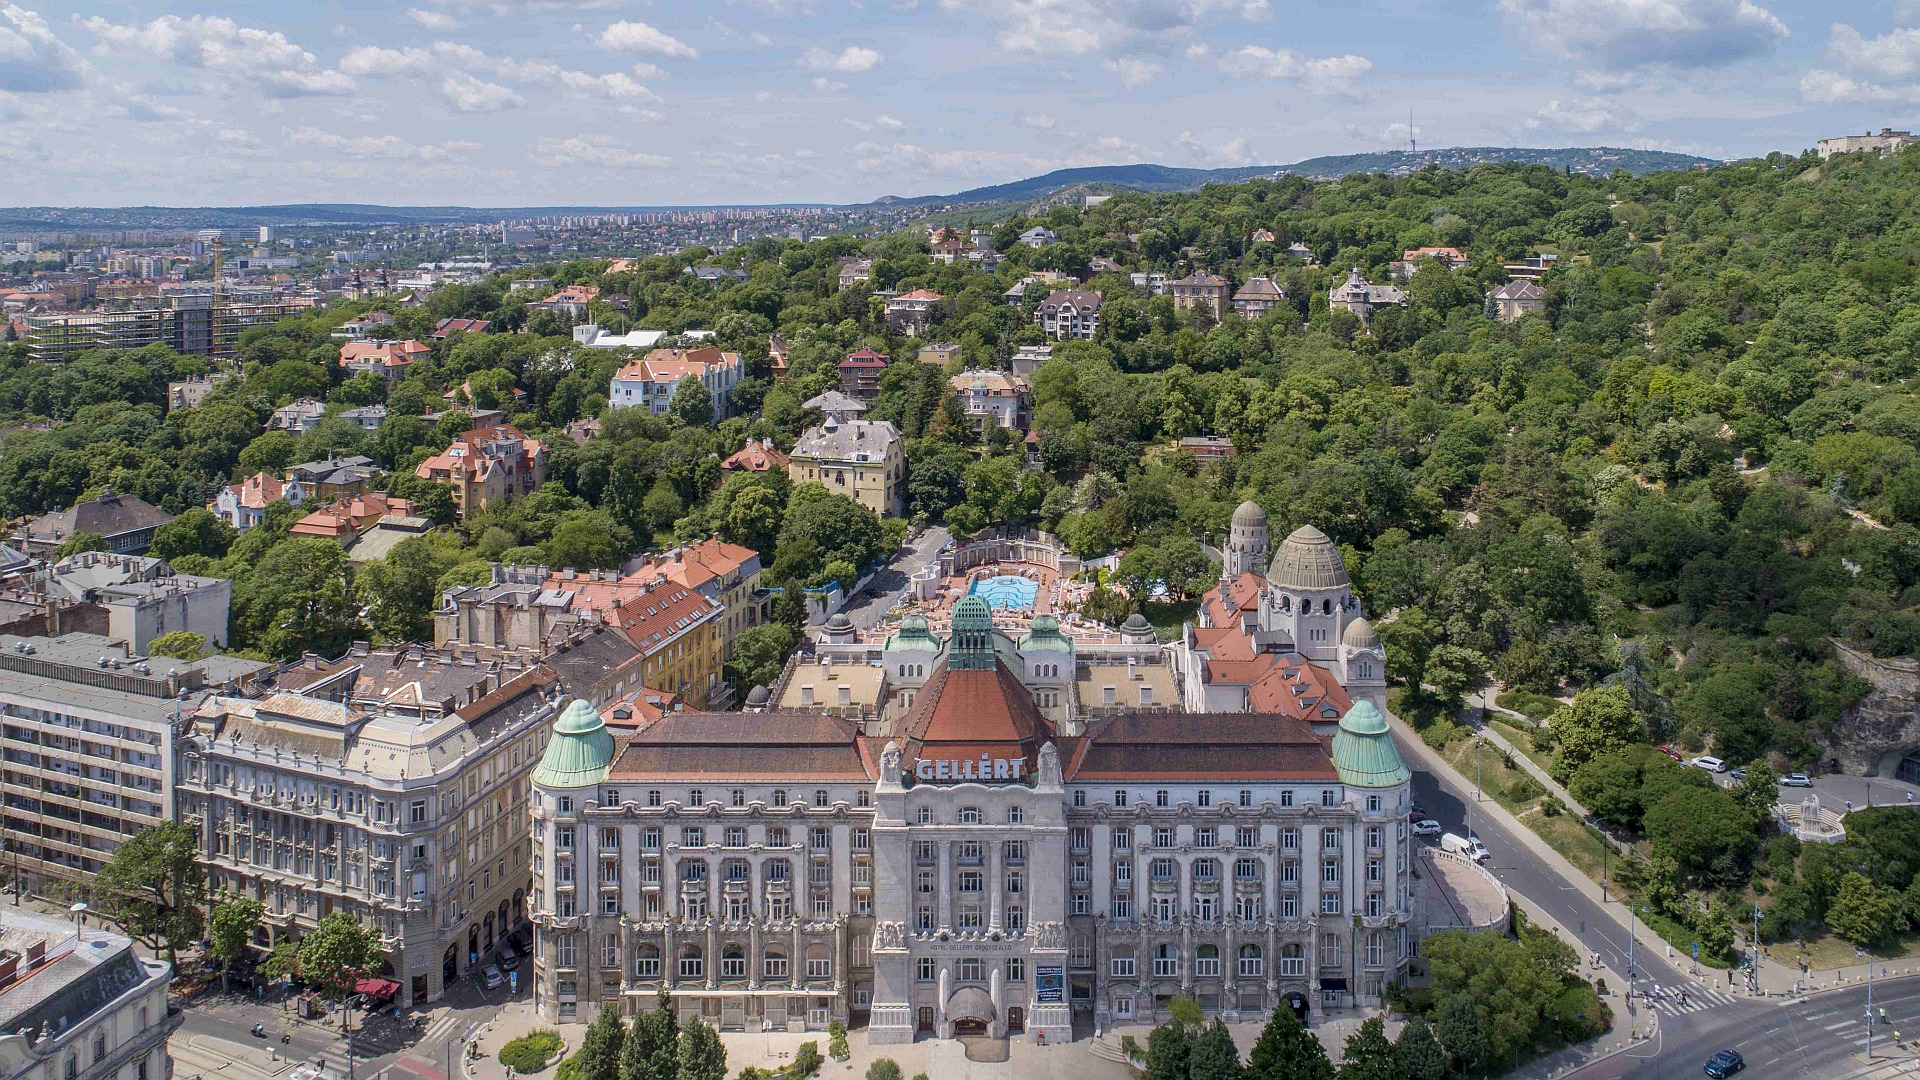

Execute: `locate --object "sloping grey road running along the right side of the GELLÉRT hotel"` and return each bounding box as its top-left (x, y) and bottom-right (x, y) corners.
top-left (1394, 732), bottom-right (1690, 994)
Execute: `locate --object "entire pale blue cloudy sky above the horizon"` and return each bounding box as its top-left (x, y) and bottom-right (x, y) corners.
top-left (0, 0), bottom-right (1920, 206)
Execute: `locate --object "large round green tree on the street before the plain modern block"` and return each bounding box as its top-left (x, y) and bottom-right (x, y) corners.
top-left (94, 821), bottom-right (207, 963)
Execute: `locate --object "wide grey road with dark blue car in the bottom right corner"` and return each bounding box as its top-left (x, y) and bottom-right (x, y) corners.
top-left (1571, 976), bottom-right (1920, 1080)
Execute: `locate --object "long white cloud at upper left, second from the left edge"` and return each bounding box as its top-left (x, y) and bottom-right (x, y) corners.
top-left (81, 15), bottom-right (353, 98)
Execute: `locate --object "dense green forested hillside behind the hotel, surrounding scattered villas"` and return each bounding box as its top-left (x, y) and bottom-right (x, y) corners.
top-left (0, 147), bottom-right (1920, 765)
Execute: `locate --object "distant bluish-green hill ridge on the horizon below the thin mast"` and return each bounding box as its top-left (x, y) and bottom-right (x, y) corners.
top-left (874, 146), bottom-right (1718, 206)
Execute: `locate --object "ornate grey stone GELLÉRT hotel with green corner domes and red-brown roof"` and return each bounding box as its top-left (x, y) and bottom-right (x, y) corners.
top-left (528, 507), bottom-right (1413, 1043)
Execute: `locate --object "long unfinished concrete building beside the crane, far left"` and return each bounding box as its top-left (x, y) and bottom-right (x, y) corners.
top-left (25, 294), bottom-right (311, 361)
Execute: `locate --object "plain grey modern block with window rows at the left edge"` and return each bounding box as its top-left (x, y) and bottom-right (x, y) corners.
top-left (0, 634), bottom-right (265, 892)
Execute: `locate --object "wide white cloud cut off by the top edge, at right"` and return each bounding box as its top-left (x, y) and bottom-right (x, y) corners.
top-left (1500, 0), bottom-right (1788, 71)
